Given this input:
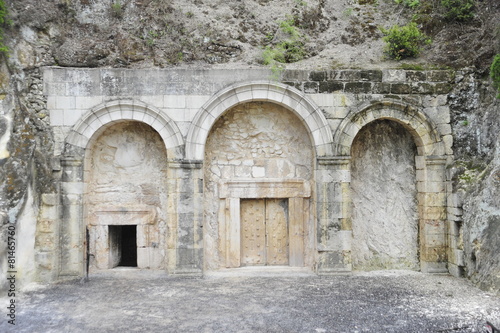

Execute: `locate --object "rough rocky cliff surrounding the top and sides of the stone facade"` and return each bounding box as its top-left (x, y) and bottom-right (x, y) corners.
top-left (0, 0), bottom-right (500, 290)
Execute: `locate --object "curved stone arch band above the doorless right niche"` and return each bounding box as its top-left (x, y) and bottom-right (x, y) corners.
top-left (334, 100), bottom-right (445, 156)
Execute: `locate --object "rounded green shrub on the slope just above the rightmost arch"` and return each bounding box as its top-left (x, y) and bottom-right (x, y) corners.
top-left (380, 22), bottom-right (431, 60)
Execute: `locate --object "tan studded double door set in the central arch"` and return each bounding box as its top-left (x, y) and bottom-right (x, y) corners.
top-left (240, 199), bottom-right (289, 266)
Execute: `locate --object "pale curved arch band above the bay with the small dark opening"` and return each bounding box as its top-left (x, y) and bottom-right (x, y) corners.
top-left (66, 100), bottom-right (184, 159)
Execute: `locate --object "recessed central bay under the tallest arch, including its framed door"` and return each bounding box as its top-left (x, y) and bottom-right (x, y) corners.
top-left (203, 102), bottom-right (314, 270)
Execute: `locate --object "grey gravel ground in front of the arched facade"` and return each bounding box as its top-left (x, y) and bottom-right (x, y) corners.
top-left (0, 269), bottom-right (500, 332)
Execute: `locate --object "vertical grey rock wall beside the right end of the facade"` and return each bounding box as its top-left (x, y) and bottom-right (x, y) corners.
top-left (449, 69), bottom-right (500, 291)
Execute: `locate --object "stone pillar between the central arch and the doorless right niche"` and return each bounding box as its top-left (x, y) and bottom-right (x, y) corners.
top-left (316, 156), bottom-right (352, 274)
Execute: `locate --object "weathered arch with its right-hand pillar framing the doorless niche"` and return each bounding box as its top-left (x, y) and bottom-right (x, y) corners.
top-left (334, 100), bottom-right (447, 273)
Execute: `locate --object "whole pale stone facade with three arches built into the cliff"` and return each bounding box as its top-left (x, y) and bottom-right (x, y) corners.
top-left (18, 68), bottom-right (463, 281)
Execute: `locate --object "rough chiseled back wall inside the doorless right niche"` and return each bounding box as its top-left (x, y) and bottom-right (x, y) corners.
top-left (351, 120), bottom-right (419, 270)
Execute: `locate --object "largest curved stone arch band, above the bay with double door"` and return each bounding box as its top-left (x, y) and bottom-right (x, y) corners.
top-left (186, 81), bottom-right (333, 160)
